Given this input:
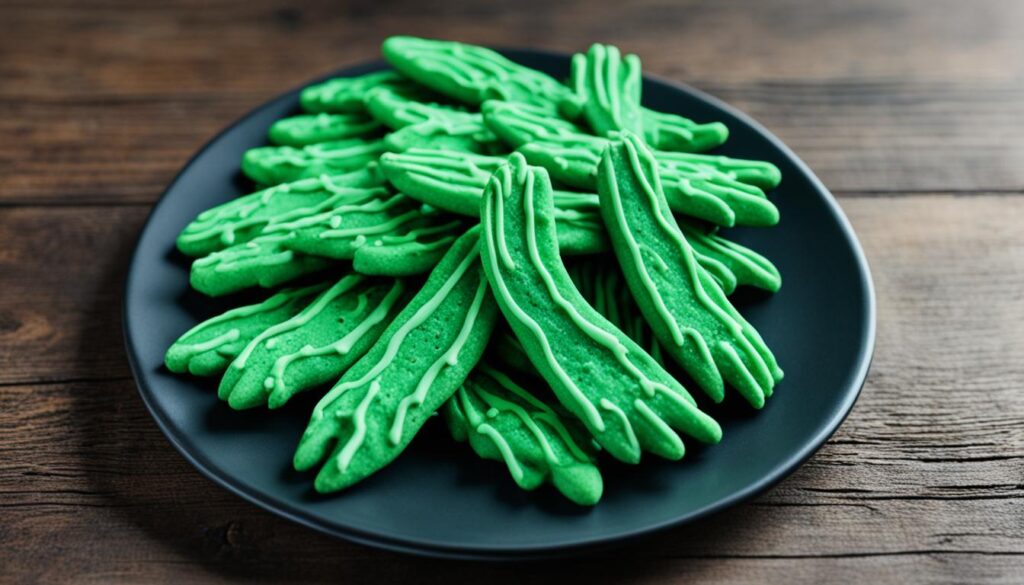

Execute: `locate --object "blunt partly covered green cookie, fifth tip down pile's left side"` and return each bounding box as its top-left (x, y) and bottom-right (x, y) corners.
top-left (188, 234), bottom-right (331, 296)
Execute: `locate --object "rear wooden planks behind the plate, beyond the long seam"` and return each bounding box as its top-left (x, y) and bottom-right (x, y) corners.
top-left (0, 0), bottom-right (1024, 204)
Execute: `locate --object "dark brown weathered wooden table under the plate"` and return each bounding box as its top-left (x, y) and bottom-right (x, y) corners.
top-left (0, 0), bottom-right (1024, 583)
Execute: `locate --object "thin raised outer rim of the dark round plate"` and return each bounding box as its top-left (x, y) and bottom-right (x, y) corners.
top-left (121, 47), bottom-right (878, 560)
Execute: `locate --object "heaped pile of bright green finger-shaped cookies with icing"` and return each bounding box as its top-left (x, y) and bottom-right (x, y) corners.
top-left (166, 37), bottom-right (782, 505)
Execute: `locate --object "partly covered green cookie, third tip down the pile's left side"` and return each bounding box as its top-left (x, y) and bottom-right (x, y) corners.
top-left (242, 138), bottom-right (386, 185)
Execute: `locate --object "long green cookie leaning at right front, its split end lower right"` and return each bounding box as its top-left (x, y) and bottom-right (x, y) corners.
top-left (598, 132), bottom-right (782, 408)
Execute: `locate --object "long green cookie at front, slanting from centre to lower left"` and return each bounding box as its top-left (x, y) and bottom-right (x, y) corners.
top-left (294, 228), bottom-right (498, 493)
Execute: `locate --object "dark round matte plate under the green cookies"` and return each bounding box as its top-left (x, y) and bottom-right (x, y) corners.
top-left (124, 50), bottom-right (874, 558)
